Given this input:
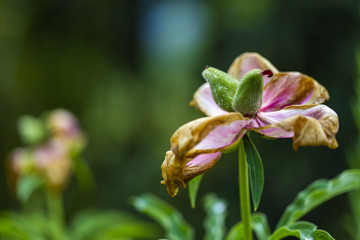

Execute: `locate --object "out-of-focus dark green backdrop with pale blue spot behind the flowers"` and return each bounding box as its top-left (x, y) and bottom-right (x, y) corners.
top-left (0, 0), bottom-right (360, 239)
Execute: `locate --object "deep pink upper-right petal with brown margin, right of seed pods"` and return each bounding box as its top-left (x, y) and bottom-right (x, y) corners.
top-left (261, 72), bottom-right (329, 111)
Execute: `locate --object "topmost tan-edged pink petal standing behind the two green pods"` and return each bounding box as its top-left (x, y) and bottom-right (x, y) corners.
top-left (228, 53), bottom-right (278, 86)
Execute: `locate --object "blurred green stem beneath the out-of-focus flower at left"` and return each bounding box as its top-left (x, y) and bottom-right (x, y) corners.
top-left (47, 191), bottom-right (66, 240)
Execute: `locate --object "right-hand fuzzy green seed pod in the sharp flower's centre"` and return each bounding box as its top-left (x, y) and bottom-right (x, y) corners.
top-left (232, 69), bottom-right (264, 117)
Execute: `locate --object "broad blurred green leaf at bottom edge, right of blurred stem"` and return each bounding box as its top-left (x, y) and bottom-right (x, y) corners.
top-left (69, 210), bottom-right (161, 240)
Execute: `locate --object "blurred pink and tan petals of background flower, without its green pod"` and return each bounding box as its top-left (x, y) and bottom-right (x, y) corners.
top-left (8, 109), bottom-right (86, 192)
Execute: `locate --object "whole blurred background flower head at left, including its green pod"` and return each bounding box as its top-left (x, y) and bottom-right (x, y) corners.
top-left (7, 109), bottom-right (86, 196)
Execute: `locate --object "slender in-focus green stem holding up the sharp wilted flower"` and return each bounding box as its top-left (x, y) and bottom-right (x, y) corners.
top-left (239, 140), bottom-right (252, 240)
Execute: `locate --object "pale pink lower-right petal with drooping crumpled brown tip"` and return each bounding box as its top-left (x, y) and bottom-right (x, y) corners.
top-left (251, 105), bottom-right (339, 149)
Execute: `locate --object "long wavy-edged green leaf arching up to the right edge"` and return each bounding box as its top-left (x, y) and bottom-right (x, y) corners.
top-left (276, 169), bottom-right (360, 228)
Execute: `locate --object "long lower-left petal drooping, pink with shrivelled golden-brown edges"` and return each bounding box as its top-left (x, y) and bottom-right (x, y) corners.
top-left (161, 113), bottom-right (251, 196)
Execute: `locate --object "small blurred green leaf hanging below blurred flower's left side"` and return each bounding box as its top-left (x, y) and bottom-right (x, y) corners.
top-left (16, 174), bottom-right (44, 204)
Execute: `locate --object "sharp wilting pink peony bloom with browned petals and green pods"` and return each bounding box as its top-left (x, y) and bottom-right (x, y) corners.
top-left (161, 53), bottom-right (339, 196)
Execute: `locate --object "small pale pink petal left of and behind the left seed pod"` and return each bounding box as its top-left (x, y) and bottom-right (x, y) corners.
top-left (190, 83), bottom-right (227, 116)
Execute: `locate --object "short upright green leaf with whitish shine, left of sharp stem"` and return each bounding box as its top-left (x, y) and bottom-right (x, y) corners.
top-left (204, 194), bottom-right (227, 240)
